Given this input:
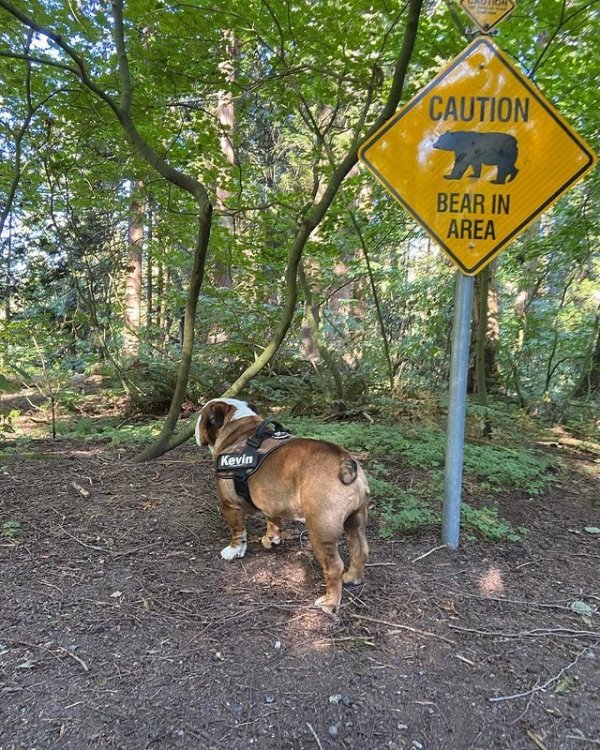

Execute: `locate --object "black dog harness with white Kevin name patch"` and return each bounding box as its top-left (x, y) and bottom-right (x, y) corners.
top-left (215, 419), bottom-right (293, 510)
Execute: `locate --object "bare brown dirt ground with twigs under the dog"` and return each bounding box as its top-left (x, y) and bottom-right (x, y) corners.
top-left (0, 426), bottom-right (600, 750)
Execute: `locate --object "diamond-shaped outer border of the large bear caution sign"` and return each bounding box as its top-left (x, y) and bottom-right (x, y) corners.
top-left (358, 37), bottom-right (597, 276)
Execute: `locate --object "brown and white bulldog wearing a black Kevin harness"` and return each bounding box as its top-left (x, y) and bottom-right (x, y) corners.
top-left (196, 398), bottom-right (369, 613)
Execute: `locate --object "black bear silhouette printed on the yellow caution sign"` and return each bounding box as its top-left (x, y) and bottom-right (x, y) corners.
top-left (433, 130), bottom-right (519, 185)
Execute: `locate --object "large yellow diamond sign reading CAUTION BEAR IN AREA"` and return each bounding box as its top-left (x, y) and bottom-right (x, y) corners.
top-left (359, 37), bottom-right (596, 275)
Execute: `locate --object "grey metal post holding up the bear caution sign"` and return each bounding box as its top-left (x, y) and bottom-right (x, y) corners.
top-left (442, 271), bottom-right (473, 549)
